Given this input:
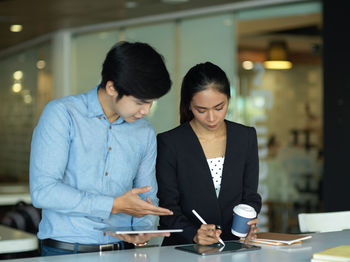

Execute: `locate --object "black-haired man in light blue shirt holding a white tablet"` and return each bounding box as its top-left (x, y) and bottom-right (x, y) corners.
top-left (30, 42), bottom-right (172, 255)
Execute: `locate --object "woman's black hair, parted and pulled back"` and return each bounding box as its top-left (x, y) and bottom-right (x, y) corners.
top-left (180, 62), bottom-right (231, 124)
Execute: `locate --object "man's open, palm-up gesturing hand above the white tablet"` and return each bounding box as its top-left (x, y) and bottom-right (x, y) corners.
top-left (112, 186), bottom-right (173, 217)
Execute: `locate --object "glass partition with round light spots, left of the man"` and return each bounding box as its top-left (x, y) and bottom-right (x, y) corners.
top-left (0, 43), bottom-right (52, 183)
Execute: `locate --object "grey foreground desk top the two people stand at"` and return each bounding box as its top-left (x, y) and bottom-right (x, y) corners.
top-left (6, 230), bottom-right (350, 262)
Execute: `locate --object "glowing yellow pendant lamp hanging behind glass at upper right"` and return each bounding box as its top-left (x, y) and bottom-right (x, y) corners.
top-left (264, 41), bottom-right (293, 69)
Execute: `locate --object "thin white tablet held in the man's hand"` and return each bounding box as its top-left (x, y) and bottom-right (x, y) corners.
top-left (95, 226), bottom-right (183, 234)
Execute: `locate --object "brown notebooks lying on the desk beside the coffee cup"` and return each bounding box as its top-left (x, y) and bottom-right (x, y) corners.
top-left (243, 232), bottom-right (311, 246)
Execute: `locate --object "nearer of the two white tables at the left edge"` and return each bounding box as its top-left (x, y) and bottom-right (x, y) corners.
top-left (0, 225), bottom-right (38, 254)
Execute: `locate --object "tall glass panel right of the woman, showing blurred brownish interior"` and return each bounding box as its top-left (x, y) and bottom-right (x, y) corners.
top-left (236, 3), bottom-right (323, 233)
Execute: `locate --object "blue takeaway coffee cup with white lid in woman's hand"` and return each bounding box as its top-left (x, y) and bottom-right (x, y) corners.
top-left (231, 204), bottom-right (256, 237)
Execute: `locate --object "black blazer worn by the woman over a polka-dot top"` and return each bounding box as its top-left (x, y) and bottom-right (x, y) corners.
top-left (157, 120), bottom-right (261, 245)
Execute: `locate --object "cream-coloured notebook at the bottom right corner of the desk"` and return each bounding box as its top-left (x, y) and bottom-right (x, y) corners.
top-left (312, 245), bottom-right (350, 261)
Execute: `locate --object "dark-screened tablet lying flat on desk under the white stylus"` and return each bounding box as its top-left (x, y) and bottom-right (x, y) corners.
top-left (175, 241), bottom-right (261, 256)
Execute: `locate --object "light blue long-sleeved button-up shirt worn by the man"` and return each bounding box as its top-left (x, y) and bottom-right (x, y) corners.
top-left (30, 88), bottom-right (158, 244)
